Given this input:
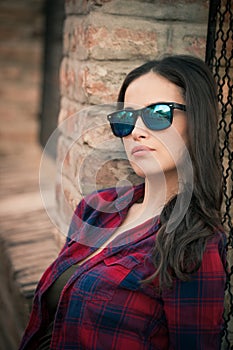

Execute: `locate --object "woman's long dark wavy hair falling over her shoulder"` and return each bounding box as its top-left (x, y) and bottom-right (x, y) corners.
top-left (118, 55), bottom-right (222, 287)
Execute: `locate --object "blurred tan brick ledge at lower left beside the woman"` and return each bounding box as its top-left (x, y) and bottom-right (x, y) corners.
top-left (0, 145), bottom-right (61, 350)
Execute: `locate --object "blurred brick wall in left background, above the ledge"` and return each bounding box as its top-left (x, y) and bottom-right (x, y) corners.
top-left (0, 0), bottom-right (44, 154)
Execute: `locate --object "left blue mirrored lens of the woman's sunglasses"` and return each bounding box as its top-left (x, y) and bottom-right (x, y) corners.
top-left (111, 110), bottom-right (134, 137)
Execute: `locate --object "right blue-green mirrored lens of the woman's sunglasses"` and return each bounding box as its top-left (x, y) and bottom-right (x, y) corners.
top-left (143, 104), bottom-right (172, 130)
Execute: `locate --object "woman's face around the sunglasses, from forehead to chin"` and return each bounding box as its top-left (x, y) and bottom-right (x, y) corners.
top-left (123, 72), bottom-right (188, 177)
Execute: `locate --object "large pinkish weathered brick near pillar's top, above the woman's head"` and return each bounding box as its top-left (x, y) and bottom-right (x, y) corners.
top-left (64, 13), bottom-right (167, 60)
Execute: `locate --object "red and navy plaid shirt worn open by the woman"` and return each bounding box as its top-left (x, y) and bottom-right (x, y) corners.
top-left (20, 185), bottom-right (225, 350)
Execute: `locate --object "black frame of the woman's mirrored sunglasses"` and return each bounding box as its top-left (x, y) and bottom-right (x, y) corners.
top-left (107, 102), bottom-right (186, 137)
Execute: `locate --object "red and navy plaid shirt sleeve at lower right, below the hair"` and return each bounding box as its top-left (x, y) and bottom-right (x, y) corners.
top-left (163, 232), bottom-right (226, 350)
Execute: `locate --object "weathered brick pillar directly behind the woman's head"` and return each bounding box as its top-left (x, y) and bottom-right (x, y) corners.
top-left (56, 0), bottom-right (209, 235)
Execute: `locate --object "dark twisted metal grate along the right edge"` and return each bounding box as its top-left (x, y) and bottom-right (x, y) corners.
top-left (206, 0), bottom-right (233, 350)
